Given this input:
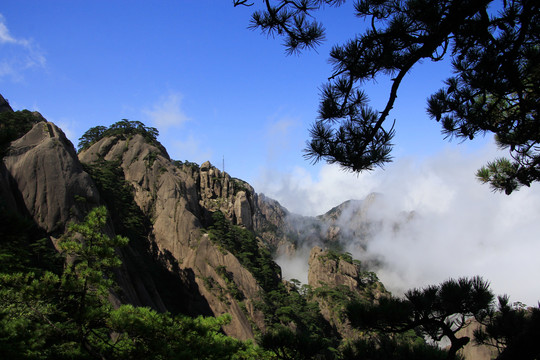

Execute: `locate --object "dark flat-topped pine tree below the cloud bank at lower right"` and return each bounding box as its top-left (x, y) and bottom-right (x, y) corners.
top-left (347, 277), bottom-right (494, 359)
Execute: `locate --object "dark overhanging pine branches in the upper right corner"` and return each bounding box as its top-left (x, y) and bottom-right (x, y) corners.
top-left (238, 0), bottom-right (540, 194)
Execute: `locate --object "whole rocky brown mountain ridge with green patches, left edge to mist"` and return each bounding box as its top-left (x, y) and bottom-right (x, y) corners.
top-left (0, 96), bottom-right (498, 354)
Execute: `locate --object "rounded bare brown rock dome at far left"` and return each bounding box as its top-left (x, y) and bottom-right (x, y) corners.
top-left (2, 119), bottom-right (100, 235)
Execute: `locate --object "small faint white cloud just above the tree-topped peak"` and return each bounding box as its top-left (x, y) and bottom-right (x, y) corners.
top-left (143, 93), bottom-right (190, 131)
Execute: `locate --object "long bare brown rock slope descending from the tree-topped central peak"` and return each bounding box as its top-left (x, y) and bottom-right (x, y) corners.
top-left (79, 135), bottom-right (264, 339)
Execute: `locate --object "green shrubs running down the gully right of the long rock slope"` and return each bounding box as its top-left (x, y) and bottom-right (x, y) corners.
top-left (208, 211), bottom-right (336, 359)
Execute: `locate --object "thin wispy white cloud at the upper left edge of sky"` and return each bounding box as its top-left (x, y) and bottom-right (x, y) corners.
top-left (0, 14), bottom-right (47, 81)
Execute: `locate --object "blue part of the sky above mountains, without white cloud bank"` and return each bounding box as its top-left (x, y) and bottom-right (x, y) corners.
top-left (0, 0), bottom-right (472, 182)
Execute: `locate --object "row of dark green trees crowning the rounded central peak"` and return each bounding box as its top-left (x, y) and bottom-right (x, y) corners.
top-left (77, 119), bottom-right (159, 151)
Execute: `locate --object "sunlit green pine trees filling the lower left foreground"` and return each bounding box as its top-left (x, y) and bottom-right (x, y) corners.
top-left (0, 207), bottom-right (269, 360)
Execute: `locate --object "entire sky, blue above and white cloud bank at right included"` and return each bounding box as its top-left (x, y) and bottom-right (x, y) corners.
top-left (0, 0), bottom-right (540, 305)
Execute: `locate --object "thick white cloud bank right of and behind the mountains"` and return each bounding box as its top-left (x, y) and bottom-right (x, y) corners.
top-left (256, 145), bottom-right (540, 305)
